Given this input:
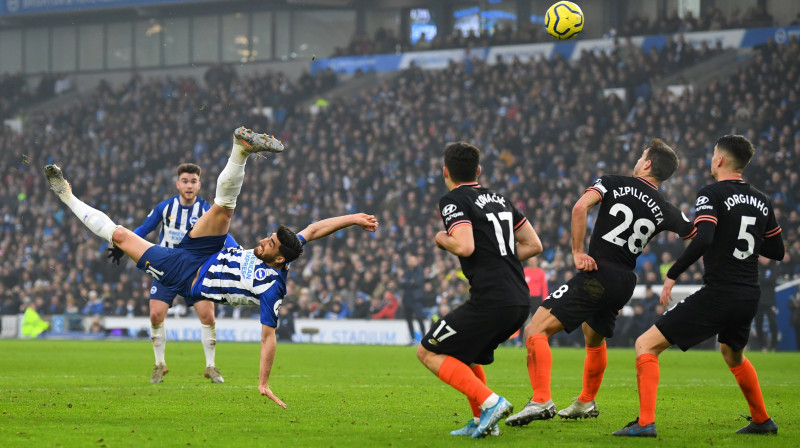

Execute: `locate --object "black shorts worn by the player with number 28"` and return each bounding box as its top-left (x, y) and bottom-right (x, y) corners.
top-left (542, 265), bottom-right (636, 338)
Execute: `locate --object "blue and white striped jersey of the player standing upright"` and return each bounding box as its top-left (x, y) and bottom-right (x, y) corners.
top-left (133, 195), bottom-right (211, 247)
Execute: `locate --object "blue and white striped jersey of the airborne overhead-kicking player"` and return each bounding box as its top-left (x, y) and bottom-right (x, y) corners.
top-left (192, 247), bottom-right (289, 327)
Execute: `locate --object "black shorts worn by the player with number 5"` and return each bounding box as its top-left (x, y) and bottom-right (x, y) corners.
top-left (656, 285), bottom-right (761, 352)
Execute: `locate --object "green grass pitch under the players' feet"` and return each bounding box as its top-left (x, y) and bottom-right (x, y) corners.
top-left (0, 340), bottom-right (800, 448)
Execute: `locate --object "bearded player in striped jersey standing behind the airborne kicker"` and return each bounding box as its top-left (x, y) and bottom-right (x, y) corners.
top-left (108, 163), bottom-right (237, 383)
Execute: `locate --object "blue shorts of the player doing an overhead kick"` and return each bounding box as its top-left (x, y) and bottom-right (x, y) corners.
top-left (136, 234), bottom-right (227, 305)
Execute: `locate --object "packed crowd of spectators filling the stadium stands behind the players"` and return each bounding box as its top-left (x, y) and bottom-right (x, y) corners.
top-left (0, 28), bottom-right (800, 346)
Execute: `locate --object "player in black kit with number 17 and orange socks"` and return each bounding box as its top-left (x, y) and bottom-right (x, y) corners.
top-left (417, 142), bottom-right (542, 438)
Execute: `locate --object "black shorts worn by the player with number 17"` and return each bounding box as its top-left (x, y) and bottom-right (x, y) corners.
top-left (422, 300), bottom-right (528, 365)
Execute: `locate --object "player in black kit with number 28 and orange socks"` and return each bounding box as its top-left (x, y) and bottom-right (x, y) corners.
top-left (506, 139), bottom-right (694, 426)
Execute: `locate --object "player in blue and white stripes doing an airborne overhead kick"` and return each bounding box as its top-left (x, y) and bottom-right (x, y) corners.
top-left (45, 128), bottom-right (378, 408)
